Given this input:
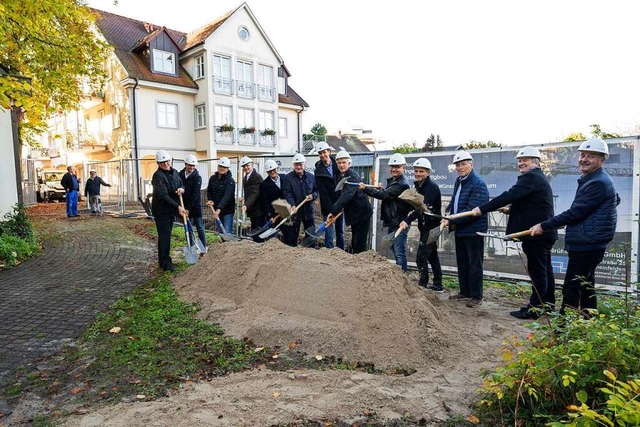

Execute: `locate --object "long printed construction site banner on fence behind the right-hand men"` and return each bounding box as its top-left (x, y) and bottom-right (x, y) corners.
top-left (373, 137), bottom-right (640, 288)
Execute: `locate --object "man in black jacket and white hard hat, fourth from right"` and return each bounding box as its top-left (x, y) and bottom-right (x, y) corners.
top-left (400, 157), bottom-right (444, 293)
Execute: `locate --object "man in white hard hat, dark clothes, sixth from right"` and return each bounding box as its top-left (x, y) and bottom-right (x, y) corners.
top-left (329, 151), bottom-right (373, 254)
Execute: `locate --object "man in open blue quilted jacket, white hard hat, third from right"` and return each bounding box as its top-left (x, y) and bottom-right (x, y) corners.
top-left (444, 151), bottom-right (489, 308)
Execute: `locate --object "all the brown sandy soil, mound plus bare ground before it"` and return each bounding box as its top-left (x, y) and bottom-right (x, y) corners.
top-left (62, 240), bottom-right (528, 426)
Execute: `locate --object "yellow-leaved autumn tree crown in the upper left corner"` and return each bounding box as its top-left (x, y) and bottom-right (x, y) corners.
top-left (0, 0), bottom-right (109, 143)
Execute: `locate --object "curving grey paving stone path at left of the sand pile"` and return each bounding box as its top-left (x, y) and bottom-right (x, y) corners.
top-left (0, 215), bottom-right (156, 382)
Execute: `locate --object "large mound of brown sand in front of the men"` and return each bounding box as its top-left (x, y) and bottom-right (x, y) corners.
top-left (174, 239), bottom-right (462, 368)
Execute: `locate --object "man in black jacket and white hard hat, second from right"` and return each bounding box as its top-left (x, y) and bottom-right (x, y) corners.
top-left (473, 147), bottom-right (558, 319)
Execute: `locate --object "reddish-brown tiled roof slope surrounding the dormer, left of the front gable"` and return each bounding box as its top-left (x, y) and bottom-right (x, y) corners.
top-left (91, 9), bottom-right (198, 89)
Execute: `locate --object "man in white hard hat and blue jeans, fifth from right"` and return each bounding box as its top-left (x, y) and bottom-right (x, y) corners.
top-left (359, 153), bottom-right (411, 271)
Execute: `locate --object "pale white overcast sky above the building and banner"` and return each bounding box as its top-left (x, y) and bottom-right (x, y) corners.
top-left (89, 0), bottom-right (640, 145)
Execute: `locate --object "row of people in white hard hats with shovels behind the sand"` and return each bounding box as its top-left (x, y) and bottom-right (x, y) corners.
top-left (152, 138), bottom-right (620, 319)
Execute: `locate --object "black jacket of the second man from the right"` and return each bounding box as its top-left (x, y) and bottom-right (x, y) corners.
top-left (479, 168), bottom-right (558, 241)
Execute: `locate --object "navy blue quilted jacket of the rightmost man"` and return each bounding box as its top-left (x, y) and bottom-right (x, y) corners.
top-left (540, 168), bottom-right (620, 251)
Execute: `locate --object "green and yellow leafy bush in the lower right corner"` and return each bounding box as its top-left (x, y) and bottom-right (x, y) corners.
top-left (478, 300), bottom-right (640, 426)
